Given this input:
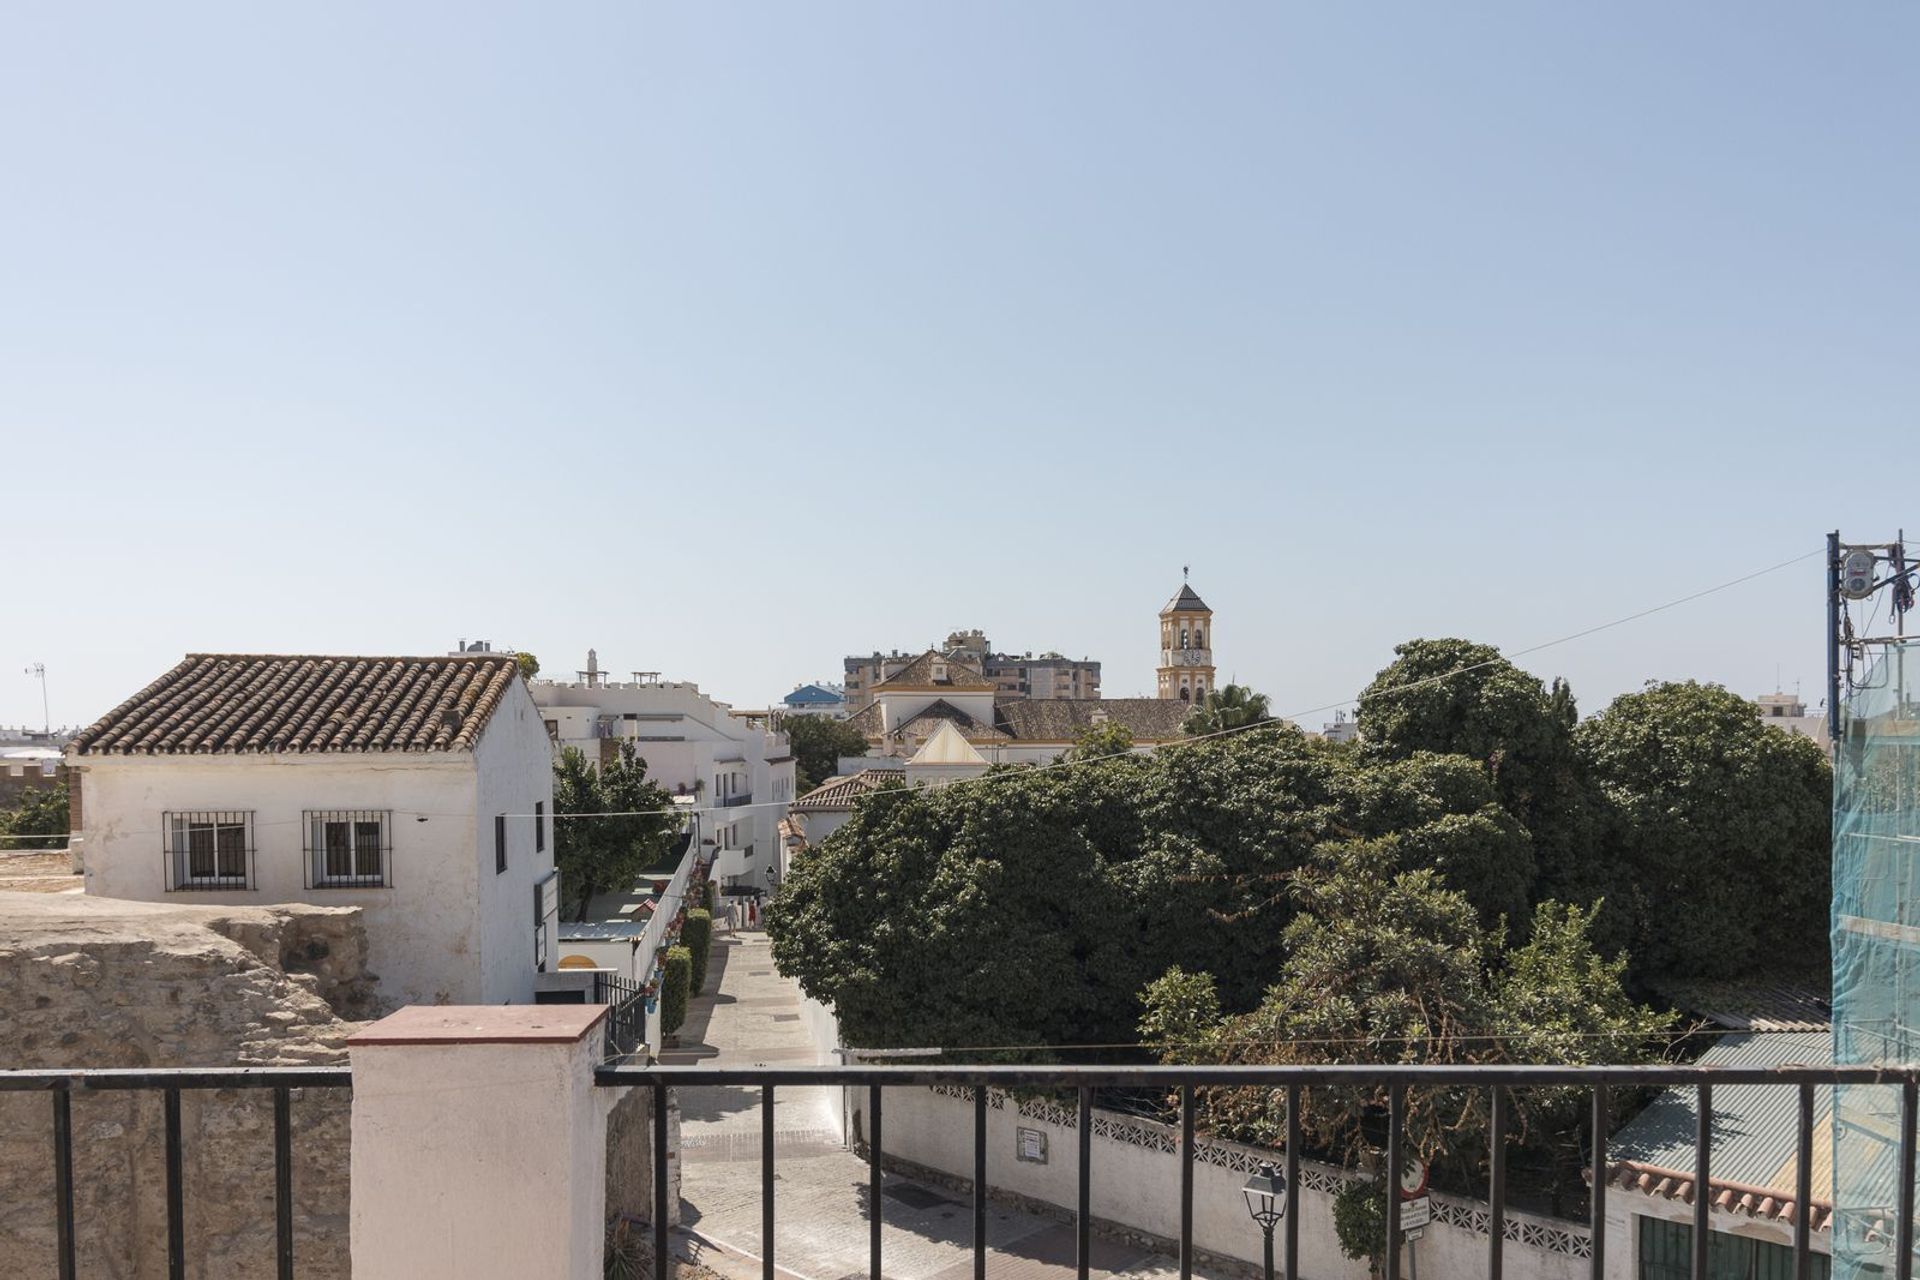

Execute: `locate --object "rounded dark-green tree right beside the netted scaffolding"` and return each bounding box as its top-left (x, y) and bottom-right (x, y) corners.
top-left (1574, 681), bottom-right (1834, 977)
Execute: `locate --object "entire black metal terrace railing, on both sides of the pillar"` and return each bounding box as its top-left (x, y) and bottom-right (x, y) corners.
top-left (0, 1065), bottom-right (1920, 1280)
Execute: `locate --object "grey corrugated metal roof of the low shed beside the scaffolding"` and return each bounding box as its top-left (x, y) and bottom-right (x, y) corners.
top-left (1607, 1031), bottom-right (1834, 1199)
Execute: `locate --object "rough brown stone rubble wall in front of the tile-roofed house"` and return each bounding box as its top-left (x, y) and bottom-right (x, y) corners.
top-left (0, 892), bottom-right (378, 1280)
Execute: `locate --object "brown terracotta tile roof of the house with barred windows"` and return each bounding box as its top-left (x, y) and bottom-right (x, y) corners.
top-left (69, 652), bottom-right (518, 756)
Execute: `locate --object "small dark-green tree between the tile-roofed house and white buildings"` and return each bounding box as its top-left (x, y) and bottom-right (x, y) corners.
top-left (553, 743), bottom-right (684, 919)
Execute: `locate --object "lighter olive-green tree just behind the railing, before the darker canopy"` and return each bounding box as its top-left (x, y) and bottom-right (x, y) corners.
top-left (1140, 839), bottom-right (1668, 1157)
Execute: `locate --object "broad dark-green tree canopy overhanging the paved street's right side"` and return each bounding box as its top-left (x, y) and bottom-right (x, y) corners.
top-left (768, 723), bottom-right (1589, 1048)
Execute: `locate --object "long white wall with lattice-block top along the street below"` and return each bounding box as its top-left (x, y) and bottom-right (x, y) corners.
top-left (851, 1088), bottom-right (1589, 1280)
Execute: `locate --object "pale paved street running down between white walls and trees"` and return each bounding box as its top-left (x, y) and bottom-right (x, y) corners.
top-left (660, 933), bottom-right (1221, 1280)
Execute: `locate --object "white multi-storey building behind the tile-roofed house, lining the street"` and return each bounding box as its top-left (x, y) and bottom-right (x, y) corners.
top-left (532, 649), bottom-right (793, 889)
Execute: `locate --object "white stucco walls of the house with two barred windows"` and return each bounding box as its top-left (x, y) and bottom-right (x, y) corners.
top-left (69, 681), bottom-right (555, 1004)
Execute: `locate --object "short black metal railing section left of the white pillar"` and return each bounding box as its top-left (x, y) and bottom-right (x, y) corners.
top-left (0, 1067), bottom-right (353, 1280)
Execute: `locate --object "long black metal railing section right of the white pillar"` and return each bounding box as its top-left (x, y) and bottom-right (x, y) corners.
top-left (595, 1065), bottom-right (1920, 1280)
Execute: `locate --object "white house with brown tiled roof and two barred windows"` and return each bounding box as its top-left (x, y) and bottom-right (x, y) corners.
top-left (67, 654), bottom-right (559, 1004)
